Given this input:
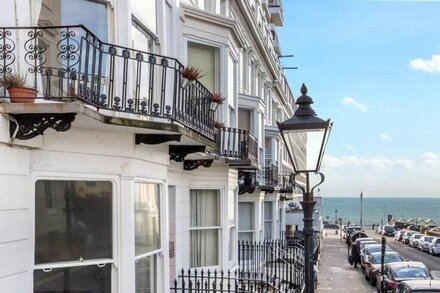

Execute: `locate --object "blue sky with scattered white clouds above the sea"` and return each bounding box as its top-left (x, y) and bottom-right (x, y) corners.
top-left (278, 0), bottom-right (440, 199)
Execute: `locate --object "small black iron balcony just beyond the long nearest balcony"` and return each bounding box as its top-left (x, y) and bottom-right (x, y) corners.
top-left (217, 127), bottom-right (258, 169)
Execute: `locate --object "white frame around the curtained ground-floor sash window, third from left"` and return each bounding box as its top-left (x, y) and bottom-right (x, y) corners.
top-left (188, 186), bottom-right (223, 269)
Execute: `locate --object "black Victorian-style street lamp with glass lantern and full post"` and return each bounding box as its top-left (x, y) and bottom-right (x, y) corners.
top-left (277, 84), bottom-right (332, 293)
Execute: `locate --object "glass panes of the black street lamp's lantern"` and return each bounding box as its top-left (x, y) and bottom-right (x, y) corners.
top-left (283, 128), bottom-right (325, 172)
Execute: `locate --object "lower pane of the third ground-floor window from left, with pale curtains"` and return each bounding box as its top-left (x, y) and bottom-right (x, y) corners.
top-left (190, 229), bottom-right (219, 268)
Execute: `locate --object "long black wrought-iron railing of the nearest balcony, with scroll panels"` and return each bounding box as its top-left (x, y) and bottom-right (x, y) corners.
top-left (0, 25), bottom-right (215, 140)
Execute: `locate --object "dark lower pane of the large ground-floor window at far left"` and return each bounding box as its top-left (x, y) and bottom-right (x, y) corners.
top-left (34, 264), bottom-right (111, 293)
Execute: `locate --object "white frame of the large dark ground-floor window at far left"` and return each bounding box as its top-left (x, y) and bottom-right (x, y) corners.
top-left (31, 172), bottom-right (120, 290)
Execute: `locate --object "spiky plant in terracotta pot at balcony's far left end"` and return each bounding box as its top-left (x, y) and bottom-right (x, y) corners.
top-left (0, 73), bottom-right (37, 103)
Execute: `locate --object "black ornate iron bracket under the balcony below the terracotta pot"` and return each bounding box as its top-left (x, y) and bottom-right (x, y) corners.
top-left (9, 113), bottom-right (76, 140)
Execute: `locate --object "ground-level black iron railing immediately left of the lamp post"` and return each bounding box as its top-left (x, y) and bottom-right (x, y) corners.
top-left (238, 239), bottom-right (304, 292)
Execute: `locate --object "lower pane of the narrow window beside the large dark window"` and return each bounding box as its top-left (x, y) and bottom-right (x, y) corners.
top-left (136, 255), bottom-right (157, 293)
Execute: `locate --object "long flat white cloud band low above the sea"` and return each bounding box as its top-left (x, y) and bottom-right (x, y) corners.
top-left (323, 155), bottom-right (414, 171)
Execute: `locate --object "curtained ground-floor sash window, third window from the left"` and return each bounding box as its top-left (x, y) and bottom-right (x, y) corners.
top-left (190, 189), bottom-right (221, 268)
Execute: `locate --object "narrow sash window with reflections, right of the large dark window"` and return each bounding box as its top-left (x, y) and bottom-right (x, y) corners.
top-left (134, 182), bottom-right (161, 293)
